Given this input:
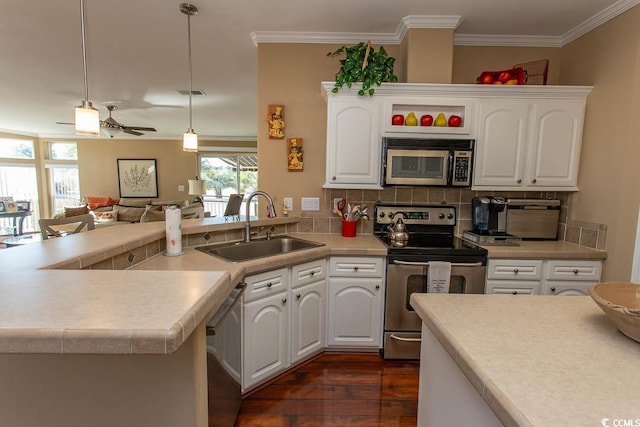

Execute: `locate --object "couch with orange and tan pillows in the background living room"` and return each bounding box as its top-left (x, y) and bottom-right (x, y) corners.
top-left (55, 196), bottom-right (208, 227)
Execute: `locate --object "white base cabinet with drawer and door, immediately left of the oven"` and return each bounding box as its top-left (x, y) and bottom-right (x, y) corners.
top-left (327, 257), bottom-right (384, 348)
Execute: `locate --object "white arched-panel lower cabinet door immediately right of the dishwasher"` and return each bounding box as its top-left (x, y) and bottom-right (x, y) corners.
top-left (242, 292), bottom-right (289, 391)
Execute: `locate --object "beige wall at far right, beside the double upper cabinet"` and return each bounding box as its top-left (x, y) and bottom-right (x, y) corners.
top-left (560, 6), bottom-right (640, 281)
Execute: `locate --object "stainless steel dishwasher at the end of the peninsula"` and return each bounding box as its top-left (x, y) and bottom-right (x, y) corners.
top-left (207, 283), bottom-right (246, 427)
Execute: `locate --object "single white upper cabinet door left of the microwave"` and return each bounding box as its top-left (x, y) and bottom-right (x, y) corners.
top-left (324, 97), bottom-right (382, 189)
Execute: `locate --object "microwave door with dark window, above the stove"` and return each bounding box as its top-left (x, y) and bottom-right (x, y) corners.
top-left (384, 148), bottom-right (450, 185)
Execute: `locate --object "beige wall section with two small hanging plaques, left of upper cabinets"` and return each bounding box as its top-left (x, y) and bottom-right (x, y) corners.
top-left (257, 43), bottom-right (401, 215)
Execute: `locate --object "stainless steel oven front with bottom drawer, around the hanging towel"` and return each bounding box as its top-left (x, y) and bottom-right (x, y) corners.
top-left (383, 260), bottom-right (486, 359)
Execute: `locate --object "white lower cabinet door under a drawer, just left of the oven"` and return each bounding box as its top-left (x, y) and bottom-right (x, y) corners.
top-left (327, 278), bottom-right (384, 347)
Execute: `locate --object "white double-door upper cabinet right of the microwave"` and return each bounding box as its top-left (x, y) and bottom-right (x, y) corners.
top-left (473, 92), bottom-right (588, 191)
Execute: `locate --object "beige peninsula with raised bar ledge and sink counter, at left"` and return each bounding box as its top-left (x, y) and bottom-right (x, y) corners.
top-left (0, 218), bottom-right (384, 427)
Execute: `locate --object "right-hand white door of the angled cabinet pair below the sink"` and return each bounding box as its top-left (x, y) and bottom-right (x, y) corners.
top-left (290, 280), bottom-right (327, 363)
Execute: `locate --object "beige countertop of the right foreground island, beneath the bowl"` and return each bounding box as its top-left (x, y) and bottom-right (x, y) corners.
top-left (411, 294), bottom-right (640, 427)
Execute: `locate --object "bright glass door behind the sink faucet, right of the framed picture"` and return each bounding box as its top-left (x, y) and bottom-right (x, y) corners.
top-left (200, 153), bottom-right (258, 216)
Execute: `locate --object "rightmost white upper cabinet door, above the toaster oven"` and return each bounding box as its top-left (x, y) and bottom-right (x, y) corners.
top-left (527, 100), bottom-right (585, 189)
